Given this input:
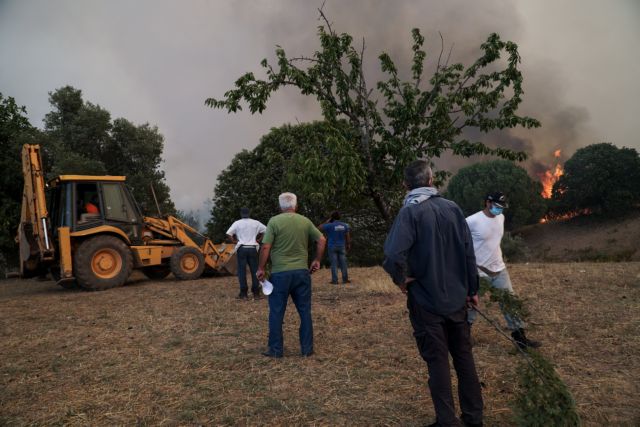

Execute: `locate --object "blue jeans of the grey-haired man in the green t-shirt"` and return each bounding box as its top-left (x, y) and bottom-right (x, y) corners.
top-left (269, 269), bottom-right (313, 356)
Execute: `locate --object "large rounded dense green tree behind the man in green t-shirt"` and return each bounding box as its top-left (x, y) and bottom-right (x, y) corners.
top-left (207, 122), bottom-right (362, 239)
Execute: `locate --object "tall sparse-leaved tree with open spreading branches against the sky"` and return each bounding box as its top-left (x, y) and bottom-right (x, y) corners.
top-left (205, 10), bottom-right (539, 224)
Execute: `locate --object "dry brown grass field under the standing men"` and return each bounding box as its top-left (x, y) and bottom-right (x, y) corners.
top-left (0, 262), bottom-right (640, 426)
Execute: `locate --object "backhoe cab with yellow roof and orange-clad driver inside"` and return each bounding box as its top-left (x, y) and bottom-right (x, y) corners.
top-left (49, 175), bottom-right (143, 244)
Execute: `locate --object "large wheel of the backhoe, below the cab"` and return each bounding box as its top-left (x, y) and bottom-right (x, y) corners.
top-left (73, 236), bottom-right (133, 291)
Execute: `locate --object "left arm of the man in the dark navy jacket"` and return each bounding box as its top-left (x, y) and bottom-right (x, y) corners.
top-left (382, 208), bottom-right (415, 287)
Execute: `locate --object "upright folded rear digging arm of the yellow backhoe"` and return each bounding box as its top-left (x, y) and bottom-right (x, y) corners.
top-left (17, 144), bottom-right (55, 277)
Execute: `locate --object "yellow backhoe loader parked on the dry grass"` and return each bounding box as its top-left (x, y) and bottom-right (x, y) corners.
top-left (16, 144), bottom-right (234, 290)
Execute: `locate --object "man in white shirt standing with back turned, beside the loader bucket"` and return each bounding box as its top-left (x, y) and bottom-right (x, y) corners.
top-left (227, 208), bottom-right (267, 300)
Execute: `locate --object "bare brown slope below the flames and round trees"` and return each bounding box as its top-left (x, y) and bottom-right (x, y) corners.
top-left (512, 213), bottom-right (640, 261)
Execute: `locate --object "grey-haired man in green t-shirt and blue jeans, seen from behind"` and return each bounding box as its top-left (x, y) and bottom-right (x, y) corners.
top-left (256, 193), bottom-right (326, 357)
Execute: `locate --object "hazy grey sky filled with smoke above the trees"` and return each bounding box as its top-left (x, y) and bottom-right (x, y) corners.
top-left (0, 0), bottom-right (640, 221)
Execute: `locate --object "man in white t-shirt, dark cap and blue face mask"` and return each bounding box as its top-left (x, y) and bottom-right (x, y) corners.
top-left (467, 192), bottom-right (540, 348)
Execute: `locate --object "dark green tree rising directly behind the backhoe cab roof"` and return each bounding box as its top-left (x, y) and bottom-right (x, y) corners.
top-left (44, 86), bottom-right (175, 214)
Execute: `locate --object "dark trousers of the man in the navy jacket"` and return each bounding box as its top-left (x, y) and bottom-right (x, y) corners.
top-left (407, 292), bottom-right (482, 426)
